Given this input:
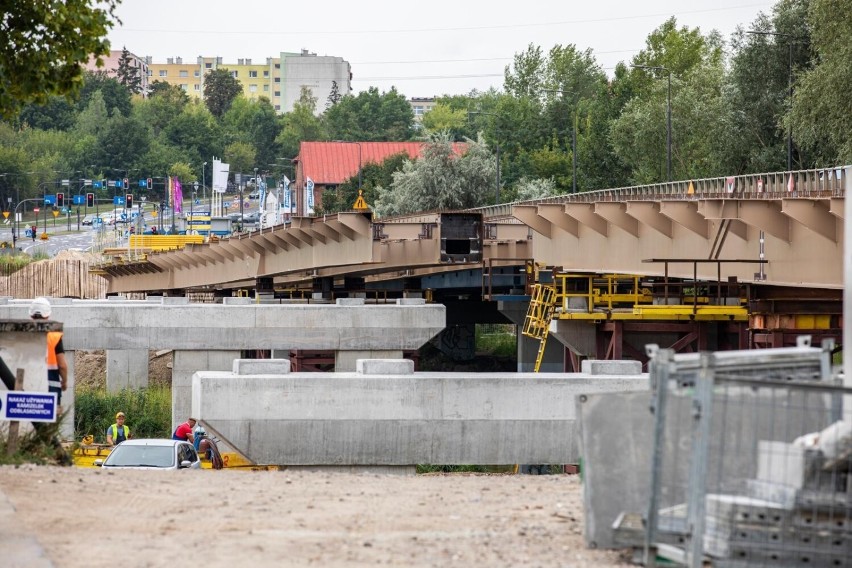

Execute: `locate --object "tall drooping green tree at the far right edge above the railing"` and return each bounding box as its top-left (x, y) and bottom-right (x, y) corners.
top-left (788, 0), bottom-right (852, 167)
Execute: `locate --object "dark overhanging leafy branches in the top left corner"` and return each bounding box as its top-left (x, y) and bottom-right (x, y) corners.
top-left (0, 0), bottom-right (120, 118)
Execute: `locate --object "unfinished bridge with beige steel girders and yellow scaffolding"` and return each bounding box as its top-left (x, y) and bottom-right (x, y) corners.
top-left (85, 167), bottom-right (850, 371)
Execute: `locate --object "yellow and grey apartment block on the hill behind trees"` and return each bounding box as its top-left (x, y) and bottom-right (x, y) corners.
top-left (146, 50), bottom-right (352, 114)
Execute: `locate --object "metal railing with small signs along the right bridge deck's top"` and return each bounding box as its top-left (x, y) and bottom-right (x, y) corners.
top-left (471, 166), bottom-right (849, 219)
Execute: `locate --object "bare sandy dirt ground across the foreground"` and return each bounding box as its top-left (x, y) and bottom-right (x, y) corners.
top-left (0, 466), bottom-right (630, 568)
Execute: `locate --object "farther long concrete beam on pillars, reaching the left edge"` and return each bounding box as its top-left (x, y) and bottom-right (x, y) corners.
top-left (0, 299), bottom-right (446, 351)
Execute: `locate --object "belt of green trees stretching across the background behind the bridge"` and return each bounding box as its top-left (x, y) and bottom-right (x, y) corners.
top-left (0, 0), bottom-right (852, 219)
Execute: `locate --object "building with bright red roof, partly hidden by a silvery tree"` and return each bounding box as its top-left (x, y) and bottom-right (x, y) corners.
top-left (293, 142), bottom-right (467, 216)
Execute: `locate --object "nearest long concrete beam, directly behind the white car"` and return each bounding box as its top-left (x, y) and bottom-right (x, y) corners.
top-left (191, 366), bottom-right (648, 466)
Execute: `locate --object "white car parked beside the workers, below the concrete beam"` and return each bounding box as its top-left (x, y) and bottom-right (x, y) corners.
top-left (95, 439), bottom-right (201, 469)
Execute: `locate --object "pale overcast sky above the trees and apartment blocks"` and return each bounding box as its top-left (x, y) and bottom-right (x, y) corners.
top-left (109, 0), bottom-right (776, 98)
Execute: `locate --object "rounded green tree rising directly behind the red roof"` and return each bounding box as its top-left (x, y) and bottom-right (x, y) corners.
top-left (324, 87), bottom-right (414, 142)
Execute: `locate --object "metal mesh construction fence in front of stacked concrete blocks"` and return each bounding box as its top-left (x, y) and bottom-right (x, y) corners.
top-left (632, 338), bottom-right (852, 567)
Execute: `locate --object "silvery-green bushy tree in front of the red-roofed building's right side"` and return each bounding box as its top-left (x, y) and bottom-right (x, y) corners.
top-left (375, 133), bottom-right (497, 216)
